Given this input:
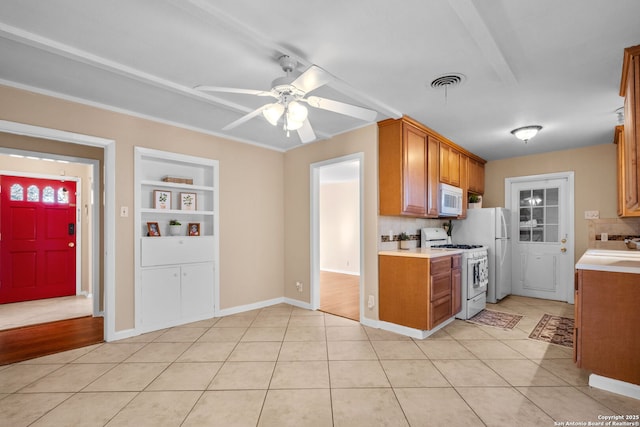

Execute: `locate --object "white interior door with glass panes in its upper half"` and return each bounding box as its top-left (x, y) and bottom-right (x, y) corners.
top-left (507, 175), bottom-right (573, 302)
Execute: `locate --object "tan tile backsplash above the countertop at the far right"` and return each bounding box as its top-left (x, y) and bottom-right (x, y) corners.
top-left (589, 218), bottom-right (640, 250)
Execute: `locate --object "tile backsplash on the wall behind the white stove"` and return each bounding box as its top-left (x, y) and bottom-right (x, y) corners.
top-left (378, 216), bottom-right (446, 251)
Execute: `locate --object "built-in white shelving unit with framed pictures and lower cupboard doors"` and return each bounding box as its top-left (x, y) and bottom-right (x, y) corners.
top-left (135, 147), bottom-right (219, 333)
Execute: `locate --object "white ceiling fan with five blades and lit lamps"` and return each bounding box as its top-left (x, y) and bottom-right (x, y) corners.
top-left (195, 55), bottom-right (377, 143)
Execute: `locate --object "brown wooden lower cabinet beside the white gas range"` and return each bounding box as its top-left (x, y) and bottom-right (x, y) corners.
top-left (378, 255), bottom-right (460, 330)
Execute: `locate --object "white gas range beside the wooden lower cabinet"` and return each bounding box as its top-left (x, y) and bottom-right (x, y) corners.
top-left (420, 228), bottom-right (489, 320)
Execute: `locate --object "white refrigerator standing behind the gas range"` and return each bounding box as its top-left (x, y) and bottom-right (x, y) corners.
top-left (451, 208), bottom-right (511, 303)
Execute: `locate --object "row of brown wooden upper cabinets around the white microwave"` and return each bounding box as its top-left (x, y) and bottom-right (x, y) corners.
top-left (378, 116), bottom-right (485, 218)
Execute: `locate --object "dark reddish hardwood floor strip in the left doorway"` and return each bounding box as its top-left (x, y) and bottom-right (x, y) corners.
top-left (0, 316), bottom-right (104, 365)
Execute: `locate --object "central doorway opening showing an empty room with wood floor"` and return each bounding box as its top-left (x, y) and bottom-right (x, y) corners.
top-left (311, 153), bottom-right (363, 321)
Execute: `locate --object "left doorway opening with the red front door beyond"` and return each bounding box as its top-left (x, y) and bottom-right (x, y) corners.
top-left (0, 149), bottom-right (102, 330)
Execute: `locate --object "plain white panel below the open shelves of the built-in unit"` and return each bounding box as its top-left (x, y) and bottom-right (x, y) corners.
top-left (140, 236), bottom-right (214, 267)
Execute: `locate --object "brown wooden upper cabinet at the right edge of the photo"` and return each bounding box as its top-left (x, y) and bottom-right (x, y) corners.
top-left (618, 45), bottom-right (640, 213)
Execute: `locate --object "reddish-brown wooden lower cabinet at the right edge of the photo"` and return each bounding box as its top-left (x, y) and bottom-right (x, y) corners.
top-left (574, 270), bottom-right (640, 385)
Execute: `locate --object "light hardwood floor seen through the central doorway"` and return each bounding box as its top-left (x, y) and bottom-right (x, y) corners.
top-left (320, 271), bottom-right (360, 321)
